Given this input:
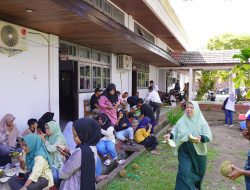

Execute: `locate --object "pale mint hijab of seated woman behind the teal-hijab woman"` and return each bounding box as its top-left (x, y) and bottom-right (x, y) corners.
top-left (45, 121), bottom-right (66, 145)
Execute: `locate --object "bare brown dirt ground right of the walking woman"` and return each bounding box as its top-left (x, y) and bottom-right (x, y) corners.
top-left (203, 111), bottom-right (250, 190)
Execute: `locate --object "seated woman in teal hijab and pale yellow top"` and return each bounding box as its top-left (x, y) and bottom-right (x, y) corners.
top-left (9, 134), bottom-right (54, 190)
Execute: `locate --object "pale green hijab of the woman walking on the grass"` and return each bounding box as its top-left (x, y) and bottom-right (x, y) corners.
top-left (172, 101), bottom-right (213, 155)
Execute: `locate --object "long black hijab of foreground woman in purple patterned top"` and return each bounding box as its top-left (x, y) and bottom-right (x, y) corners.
top-left (73, 118), bottom-right (101, 190)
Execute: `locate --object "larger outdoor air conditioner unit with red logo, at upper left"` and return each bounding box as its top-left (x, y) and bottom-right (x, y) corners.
top-left (0, 21), bottom-right (27, 51)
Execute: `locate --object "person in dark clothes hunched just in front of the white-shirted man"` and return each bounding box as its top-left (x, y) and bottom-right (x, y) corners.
top-left (137, 98), bottom-right (157, 134)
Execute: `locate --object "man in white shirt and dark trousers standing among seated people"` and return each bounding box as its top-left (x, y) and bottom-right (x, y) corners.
top-left (145, 86), bottom-right (161, 123)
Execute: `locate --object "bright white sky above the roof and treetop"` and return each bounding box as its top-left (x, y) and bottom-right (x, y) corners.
top-left (169, 0), bottom-right (250, 50)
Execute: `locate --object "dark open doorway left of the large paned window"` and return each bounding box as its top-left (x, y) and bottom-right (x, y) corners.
top-left (59, 61), bottom-right (78, 126)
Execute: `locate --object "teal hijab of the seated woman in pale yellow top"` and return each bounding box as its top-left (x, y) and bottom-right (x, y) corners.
top-left (23, 134), bottom-right (51, 170)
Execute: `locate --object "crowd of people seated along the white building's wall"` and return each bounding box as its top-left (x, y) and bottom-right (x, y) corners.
top-left (0, 82), bottom-right (161, 190)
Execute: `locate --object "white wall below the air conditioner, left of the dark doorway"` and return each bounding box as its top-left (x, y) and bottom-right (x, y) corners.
top-left (0, 30), bottom-right (59, 131)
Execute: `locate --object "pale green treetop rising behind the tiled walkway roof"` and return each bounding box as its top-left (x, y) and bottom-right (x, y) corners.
top-left (207, 33), bottom-right (250, 50)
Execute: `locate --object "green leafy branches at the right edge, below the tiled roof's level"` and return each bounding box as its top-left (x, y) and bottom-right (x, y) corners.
top-left (231, 46), bottom-right (250, 99)
